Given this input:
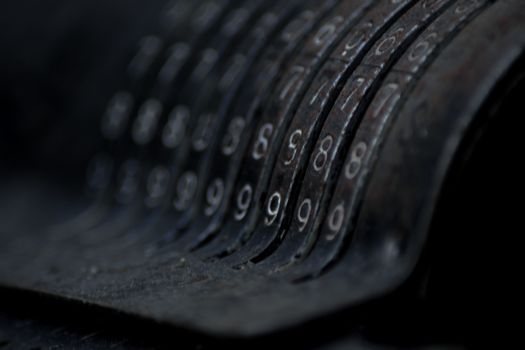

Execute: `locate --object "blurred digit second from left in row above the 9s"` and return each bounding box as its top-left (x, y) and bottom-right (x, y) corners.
top-left (132, 99), bottom-right (162, 145)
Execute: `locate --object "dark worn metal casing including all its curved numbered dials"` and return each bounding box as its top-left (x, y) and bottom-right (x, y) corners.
top-left (0, 0), bottom-right (525, 344)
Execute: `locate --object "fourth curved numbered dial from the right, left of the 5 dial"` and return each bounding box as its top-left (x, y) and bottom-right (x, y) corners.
top-left (196, 1), bottom-right (340, 257)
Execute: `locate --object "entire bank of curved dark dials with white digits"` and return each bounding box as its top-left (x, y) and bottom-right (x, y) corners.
top-left (87, 0), bottom-right (492, 277)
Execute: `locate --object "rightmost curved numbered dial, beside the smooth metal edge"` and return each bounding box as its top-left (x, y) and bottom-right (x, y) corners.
top-left (289, 0), bottom-right (488, 278)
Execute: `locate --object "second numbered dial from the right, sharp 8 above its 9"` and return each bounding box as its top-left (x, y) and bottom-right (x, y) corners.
top-left (258, 1), bottom-right (450, 272)
